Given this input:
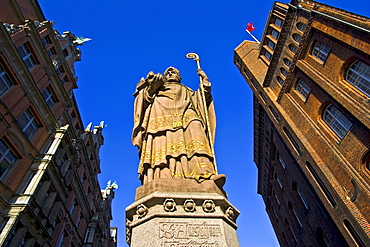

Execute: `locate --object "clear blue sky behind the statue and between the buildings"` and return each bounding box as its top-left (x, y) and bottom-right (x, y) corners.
top-left (39, 0), bottom-right (370, 247)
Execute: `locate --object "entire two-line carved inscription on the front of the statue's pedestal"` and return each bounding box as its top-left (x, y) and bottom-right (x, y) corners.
top-left (159, 222), bottom-right (221, 247)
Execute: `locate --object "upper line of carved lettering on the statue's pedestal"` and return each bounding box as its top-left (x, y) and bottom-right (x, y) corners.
top-left (159, 222), bottom-right (221, 239)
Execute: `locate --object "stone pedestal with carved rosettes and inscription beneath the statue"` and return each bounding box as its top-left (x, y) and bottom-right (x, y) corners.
top-left (126, 179), bottom-right (239, 247)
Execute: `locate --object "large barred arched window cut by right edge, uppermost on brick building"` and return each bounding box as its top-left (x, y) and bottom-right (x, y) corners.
top-left (346, 60), bottom-right (370, 97)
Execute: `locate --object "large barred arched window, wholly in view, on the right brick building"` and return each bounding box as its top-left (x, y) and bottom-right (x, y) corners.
top-left (323, 105), bottom-right (352, 139)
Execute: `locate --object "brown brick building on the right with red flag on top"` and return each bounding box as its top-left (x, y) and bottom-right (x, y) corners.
top-left (234, 0), bottom-right (370, 246)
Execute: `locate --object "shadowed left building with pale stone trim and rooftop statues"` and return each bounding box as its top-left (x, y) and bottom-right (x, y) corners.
top-left (0, 0), bottom-right (115, 246)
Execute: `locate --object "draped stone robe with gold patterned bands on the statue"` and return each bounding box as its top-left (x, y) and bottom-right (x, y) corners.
top-left (132, 82), bottom-right (216, 184)
